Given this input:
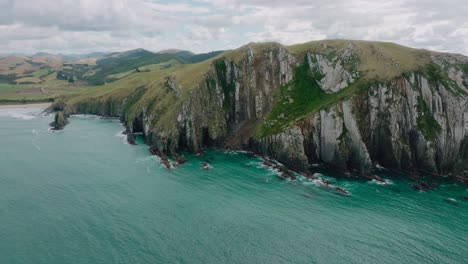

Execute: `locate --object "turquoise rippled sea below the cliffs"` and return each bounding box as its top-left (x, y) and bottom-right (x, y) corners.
top-left (0, 106), bottom-right (468, 264)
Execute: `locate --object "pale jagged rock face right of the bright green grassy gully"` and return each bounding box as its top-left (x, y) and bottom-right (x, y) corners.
top-left (254, 71), bottom-right (468, 174)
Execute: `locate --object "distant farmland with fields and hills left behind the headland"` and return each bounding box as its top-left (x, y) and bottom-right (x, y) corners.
top-left (0, 49), bottom-right (225, 102)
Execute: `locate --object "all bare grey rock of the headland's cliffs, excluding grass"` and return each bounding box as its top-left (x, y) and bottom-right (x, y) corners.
top-left (60, 44), bottom-right (468, 179)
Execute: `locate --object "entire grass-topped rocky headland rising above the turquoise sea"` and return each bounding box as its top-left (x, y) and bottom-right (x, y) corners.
top-left (56, 41), bottom-right (468, 179)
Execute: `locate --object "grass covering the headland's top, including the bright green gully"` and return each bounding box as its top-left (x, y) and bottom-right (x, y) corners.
top-left (53, 40), bottom-right (468, 138)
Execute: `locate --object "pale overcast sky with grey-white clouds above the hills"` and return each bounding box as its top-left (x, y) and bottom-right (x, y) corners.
top-left (0, 0), bottom-right (468, 54)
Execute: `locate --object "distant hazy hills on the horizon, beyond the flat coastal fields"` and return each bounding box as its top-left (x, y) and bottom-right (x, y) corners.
top-left (0, 49), bottom-right (223, 85)
